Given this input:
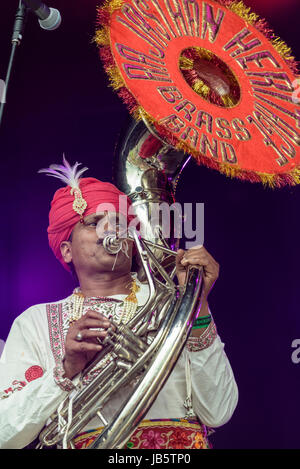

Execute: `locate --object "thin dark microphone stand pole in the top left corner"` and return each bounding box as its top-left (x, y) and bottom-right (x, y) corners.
top-left (0, 0), bottom-right (28, 126)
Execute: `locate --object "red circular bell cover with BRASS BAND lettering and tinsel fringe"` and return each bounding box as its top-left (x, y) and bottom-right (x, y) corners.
top-left (96, 0), bottom-right (300, 186)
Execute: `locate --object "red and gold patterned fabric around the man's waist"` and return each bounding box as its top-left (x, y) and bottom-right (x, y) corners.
top-left (73, 419), bottom-right (211, 449)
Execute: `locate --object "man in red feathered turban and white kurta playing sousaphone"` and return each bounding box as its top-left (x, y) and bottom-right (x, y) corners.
top-left (0, 160), bottom-right (238, 449)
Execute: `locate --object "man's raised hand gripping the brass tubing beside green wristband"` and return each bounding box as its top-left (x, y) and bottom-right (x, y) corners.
top-left (176, 246), bottom-right (220, 302)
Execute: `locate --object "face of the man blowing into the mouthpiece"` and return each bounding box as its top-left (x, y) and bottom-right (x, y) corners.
top-left (62, 212), bottom-right (133, 276)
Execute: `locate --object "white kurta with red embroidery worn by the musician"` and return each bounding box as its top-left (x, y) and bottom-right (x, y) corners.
top-left (0, 276), bottom-right (238, 449)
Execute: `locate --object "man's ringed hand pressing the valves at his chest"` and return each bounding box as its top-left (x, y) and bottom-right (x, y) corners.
top-left (64, 310), bottom-right (111, 379)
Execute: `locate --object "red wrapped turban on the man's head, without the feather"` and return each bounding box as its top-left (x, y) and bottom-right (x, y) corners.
top-left (48, 178), bottom-right (135, 270)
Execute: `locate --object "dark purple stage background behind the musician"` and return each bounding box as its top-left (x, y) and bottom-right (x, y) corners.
top-left (0, 0), bottom-right (300, 449)
